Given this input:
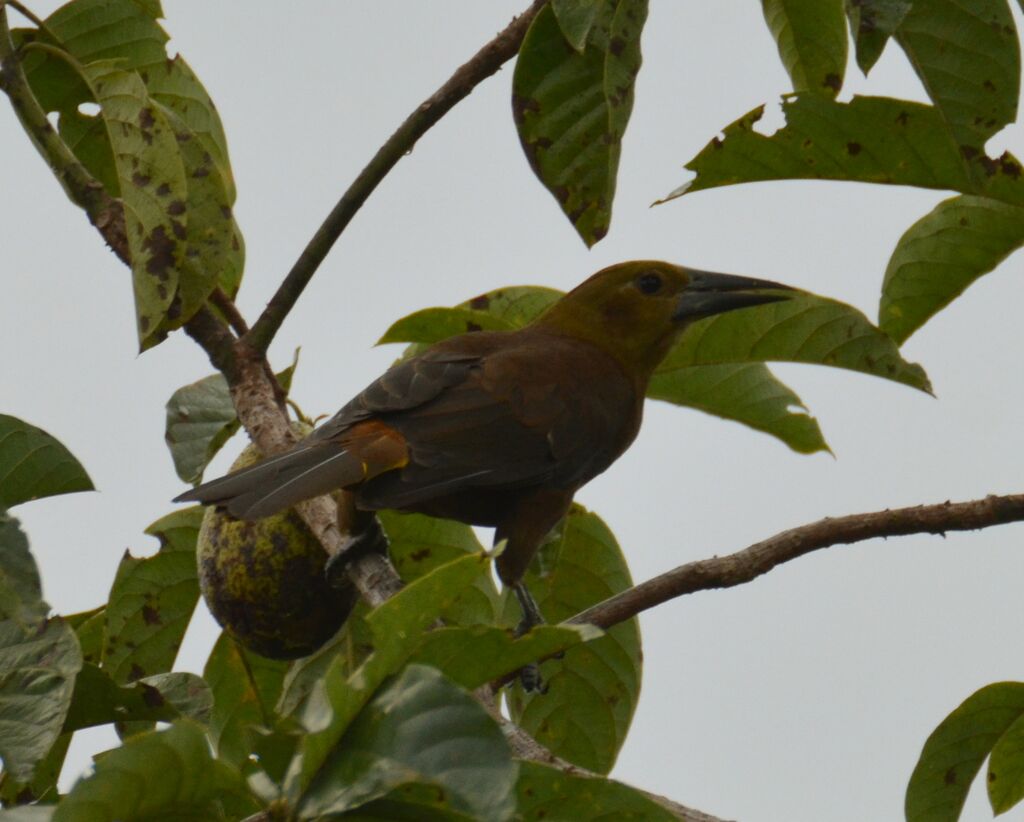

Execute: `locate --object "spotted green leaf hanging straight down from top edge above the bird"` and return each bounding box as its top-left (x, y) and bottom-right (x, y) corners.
top-left (512, 0), bottom-right (647, 246)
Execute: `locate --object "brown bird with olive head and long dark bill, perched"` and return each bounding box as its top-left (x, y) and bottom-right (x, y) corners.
top-left (175, 260), bottom-right (792, 630)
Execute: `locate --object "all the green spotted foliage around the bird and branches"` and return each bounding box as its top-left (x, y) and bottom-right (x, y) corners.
top-left (0, 0), bottom-right (1024, 820)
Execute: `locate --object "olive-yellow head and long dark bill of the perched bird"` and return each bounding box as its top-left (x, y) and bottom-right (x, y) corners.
top-left (538, 260), bottom-right (793, 377)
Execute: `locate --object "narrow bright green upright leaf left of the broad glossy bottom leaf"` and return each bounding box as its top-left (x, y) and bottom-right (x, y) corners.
top-left (285, 554), bottom-right (490, 798)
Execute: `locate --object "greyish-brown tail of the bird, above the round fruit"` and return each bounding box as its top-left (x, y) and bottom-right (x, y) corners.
top-left (174, 443), bottom-right (366, 519)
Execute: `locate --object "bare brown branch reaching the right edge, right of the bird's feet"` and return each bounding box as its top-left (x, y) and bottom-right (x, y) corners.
top-left (568, 493), bottom-right (1024, 628)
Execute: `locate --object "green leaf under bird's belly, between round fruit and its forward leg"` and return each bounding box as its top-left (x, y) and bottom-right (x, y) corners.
top-left (377, 511), bottom-right (500, 625)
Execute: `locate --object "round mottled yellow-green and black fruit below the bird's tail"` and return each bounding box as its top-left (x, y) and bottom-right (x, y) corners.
top-left (197, 428), bottom-right (357, 659)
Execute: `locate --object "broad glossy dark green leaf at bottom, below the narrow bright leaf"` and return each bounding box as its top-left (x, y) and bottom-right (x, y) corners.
top-left (299, 664), bottom-right (517, 820)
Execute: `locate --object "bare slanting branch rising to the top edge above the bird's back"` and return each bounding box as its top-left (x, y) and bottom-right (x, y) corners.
top-left (246, 0), bottom-right (547, 352)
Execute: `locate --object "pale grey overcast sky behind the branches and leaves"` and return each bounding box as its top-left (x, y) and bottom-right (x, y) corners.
top-left (0, 0), bottom-right (1024, 822)
